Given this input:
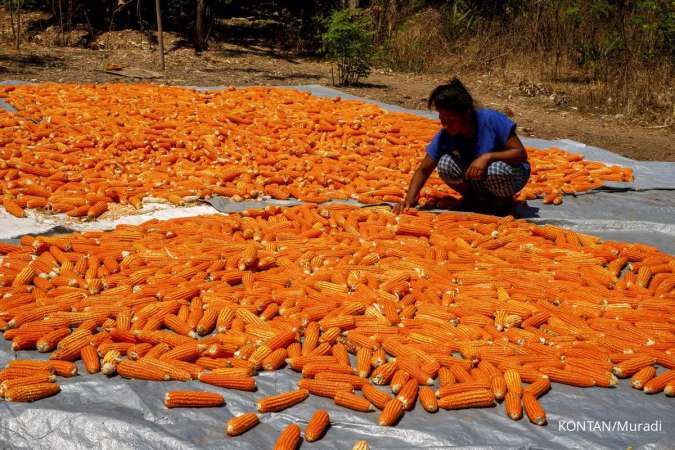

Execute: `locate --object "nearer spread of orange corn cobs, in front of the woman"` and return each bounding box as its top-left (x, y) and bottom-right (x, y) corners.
top-left (0, 205), bottom-right (675, 448)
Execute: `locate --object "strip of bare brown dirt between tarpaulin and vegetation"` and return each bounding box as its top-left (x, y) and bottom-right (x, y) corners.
top-left (0, 31), bottom-right (675, 161)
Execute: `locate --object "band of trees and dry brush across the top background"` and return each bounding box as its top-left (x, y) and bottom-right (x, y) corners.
top-left (0, 0), bottom-right (675, 159)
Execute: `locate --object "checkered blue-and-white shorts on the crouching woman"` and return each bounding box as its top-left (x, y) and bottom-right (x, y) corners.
top-left (437, 154), bottom-right (530, 197)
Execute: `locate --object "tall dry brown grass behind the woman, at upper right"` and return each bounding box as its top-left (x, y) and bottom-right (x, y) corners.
top-left (380, 8), bottom-right (675, 128)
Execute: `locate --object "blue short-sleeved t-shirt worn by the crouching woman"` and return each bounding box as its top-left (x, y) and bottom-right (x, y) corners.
top-left (427, 109), bottom-right (529, 169)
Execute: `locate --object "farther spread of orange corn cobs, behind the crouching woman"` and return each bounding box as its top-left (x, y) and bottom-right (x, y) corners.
top-left (0, 84), bottom-right (632, 219)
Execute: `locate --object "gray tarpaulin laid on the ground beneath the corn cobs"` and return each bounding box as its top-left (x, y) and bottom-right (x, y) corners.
top-left (0, 82), bottom-right (675, 450)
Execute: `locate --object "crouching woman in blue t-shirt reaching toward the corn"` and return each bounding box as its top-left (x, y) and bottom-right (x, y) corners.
top-left (394, 78), bottom-right (530, 214)
